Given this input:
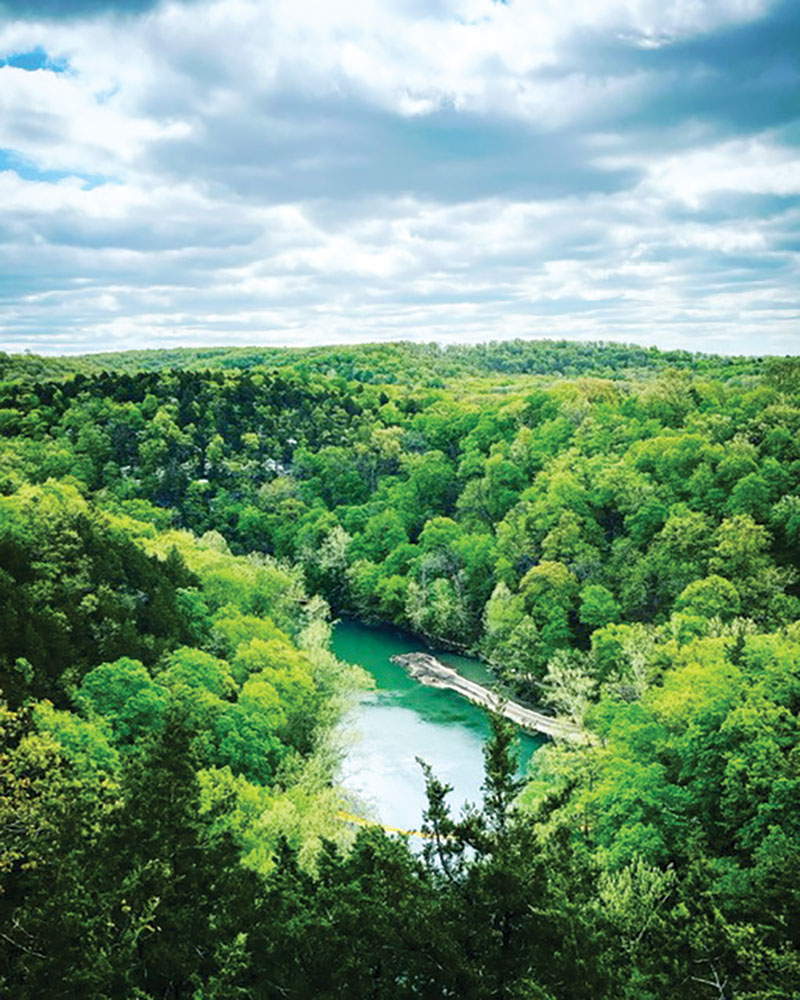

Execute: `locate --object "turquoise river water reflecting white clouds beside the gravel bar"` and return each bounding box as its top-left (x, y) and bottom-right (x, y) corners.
top-left (333, 621), bottom-right (544, 830)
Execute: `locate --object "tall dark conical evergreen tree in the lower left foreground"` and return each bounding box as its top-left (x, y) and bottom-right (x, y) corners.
top-left (100, 701), bottom-right (256, 997)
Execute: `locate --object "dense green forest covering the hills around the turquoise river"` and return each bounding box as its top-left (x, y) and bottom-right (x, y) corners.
top-left (0, 341), bottom-right (800, 1000)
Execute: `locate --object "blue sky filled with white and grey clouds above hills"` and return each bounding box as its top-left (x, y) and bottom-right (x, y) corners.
top-left (0, 0), bottom-right (800, 354)
